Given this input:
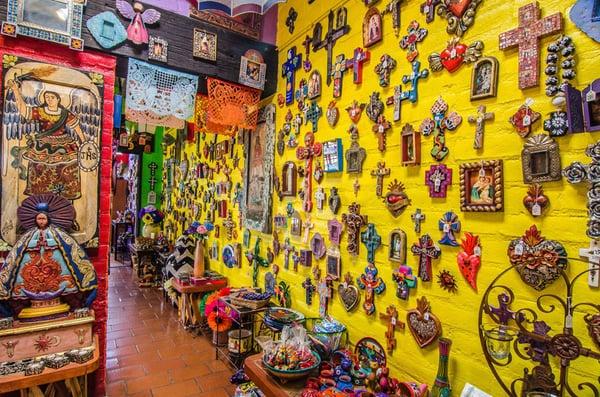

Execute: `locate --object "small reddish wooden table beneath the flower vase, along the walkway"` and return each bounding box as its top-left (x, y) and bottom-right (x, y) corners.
top-left (173, 278), bottom-right (227, 328)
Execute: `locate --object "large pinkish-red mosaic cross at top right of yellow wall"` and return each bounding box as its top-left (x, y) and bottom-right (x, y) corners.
top-left (500, 1), bottom-right (563, 90)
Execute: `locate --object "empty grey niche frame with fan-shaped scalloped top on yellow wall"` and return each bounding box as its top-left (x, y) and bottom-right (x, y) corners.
top-left (521, 134), bottom-right (562, 184)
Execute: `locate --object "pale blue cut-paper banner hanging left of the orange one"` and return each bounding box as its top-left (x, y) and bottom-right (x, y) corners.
top-left (125, 58), bottom-right (198, 129)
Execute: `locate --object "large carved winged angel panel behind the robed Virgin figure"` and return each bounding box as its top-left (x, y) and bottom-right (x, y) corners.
top-left (0, 54), bottom-right (104, 247)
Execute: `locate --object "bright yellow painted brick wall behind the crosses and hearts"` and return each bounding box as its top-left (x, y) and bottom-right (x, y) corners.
top-left (164, 0), bottom-right (600, 396)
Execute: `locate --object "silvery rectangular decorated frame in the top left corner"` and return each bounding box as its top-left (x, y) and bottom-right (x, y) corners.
top-left (2, 0), bottom-right (86, 51)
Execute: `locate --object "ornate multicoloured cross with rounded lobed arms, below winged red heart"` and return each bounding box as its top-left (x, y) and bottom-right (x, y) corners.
top-left (420, 97), bottom-right (462, 161)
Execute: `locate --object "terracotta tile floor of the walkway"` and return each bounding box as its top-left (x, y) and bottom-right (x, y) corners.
top-left (106, 266), bottom-right (235, 397)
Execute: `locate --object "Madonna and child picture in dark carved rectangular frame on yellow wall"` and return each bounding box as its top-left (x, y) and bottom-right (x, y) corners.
top-left (460, 160), bottom-right (504, 212)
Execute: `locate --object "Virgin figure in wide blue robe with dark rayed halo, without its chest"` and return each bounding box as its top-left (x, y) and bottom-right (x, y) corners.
top-left (0, 194), bottom-right (98, 321)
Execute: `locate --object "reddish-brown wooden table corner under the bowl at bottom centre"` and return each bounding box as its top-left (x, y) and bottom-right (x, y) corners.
top-left (244, 353), bottom-right (306, 397)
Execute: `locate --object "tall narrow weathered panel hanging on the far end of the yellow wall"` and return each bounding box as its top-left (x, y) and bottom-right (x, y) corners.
top-left (241, 104), bottom-right (275, 233)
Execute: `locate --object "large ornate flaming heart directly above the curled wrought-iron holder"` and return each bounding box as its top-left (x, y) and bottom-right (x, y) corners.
top-left (508, 225), bottom-right (567, 291)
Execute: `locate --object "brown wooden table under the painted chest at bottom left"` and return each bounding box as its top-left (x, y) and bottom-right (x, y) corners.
top-left (0, 337), bottom-right (100, 397)
